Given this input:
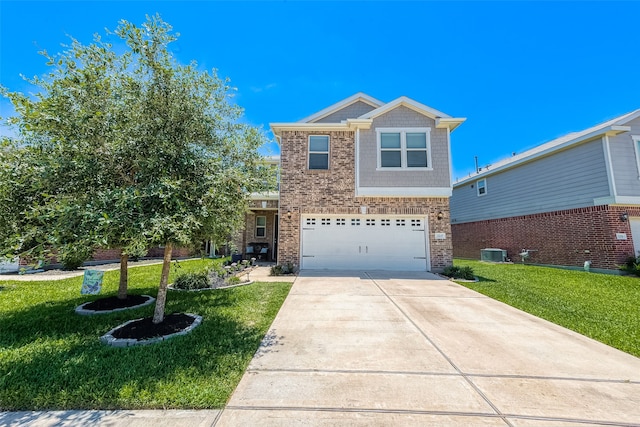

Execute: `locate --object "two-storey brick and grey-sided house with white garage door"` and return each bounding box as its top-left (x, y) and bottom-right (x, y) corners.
top-left (249, 93), bottom-right (465, 271)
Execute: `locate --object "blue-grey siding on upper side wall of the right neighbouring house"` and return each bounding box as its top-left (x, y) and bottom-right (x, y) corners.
top-left (451, 139), bottom-right (610, 223)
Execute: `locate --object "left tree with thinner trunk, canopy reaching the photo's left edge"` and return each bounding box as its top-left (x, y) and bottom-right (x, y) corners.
top-left (0, 25), bottom-right (143, 290)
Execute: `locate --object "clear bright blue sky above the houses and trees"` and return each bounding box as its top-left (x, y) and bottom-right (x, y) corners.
top-left (0, 0), bottom-right (640, 178)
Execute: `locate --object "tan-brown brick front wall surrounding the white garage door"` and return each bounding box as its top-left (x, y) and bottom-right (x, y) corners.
top-left (277, 131), bottom-right (453, 270)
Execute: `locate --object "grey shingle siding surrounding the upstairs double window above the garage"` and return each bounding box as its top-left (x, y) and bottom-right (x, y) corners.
top-left (359, 106), bottom-right (451, 187)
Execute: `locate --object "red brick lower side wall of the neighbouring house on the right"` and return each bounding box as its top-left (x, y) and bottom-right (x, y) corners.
top-left (451, 206), bottom-right (640, 269)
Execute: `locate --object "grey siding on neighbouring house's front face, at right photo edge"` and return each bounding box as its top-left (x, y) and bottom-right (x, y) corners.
top-left (609, 118), bottom-right (640, 196)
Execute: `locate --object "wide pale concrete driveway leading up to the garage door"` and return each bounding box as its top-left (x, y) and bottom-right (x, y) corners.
top-left (216, 271), bottom-right (640, 427)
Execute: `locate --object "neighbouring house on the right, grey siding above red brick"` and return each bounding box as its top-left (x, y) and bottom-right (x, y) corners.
top-left (451, 110), bottom-right (640, 269)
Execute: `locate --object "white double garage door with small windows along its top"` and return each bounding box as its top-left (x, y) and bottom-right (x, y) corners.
top-left (301, 215), bottom-right (430, 271)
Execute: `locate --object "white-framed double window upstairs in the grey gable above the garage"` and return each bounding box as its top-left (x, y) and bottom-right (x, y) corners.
top-left (376, 128), bottom-right (432, 169)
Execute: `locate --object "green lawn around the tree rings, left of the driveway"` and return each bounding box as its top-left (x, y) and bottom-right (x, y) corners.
top-left (0, 260), bottom-right (291, 410)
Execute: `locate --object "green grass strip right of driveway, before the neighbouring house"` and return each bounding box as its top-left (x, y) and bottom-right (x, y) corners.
top-left (455, 260), bottom-right (640, 356)
